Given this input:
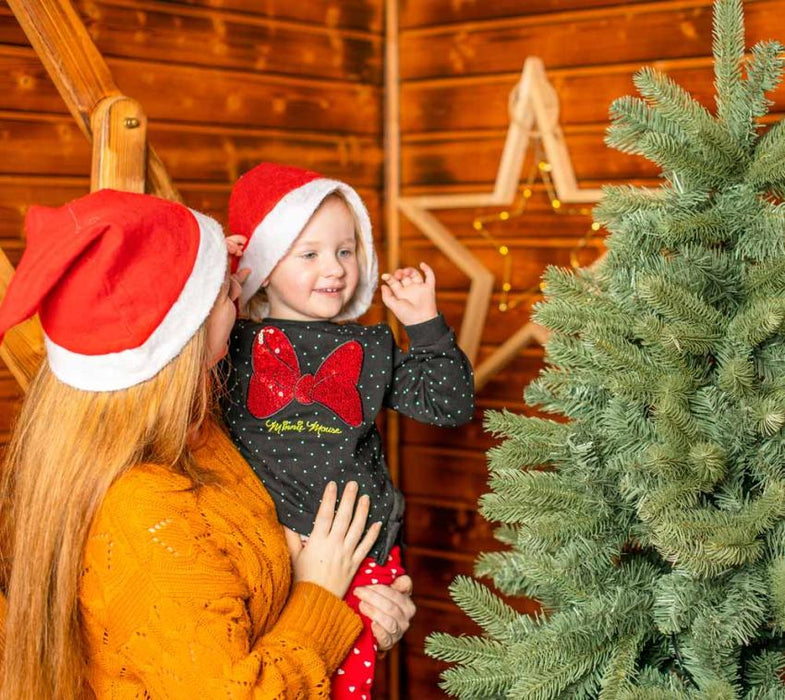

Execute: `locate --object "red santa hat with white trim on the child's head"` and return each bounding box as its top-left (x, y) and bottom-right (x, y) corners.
top-left (229, 163), bottom-right (378, 321)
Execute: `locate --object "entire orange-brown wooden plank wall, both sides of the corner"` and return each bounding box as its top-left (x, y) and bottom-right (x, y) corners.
top-left (7, 0), bottom-right (785, 700)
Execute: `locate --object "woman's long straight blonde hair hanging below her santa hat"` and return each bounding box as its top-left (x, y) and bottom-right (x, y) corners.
top-left (0, 326), bottom-right (210, 700)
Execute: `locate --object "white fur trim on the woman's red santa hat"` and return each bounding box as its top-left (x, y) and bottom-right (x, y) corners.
top-left (44, 210), bottom-right (227, 391)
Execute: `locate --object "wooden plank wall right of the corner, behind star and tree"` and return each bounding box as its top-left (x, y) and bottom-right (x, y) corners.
top-left (399, 0), bottom-right (785, 700)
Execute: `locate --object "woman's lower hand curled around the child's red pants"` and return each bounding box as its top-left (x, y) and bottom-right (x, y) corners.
top-left (354, 576), bottom-right (417, 651)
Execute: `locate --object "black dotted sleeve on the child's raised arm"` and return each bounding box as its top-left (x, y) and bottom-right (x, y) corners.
top-left (385, 314), bottom-right (474, 427)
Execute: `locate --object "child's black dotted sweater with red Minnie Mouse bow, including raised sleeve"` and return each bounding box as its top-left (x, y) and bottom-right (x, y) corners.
top-left (224, 316), bottom-right (474, 563)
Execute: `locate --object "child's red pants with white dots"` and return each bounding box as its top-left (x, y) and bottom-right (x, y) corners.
top-left (330, 546), bottom-right (406, 700)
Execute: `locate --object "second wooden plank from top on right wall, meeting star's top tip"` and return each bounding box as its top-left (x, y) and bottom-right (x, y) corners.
top-left (401, 0), bottom-right (785, 80)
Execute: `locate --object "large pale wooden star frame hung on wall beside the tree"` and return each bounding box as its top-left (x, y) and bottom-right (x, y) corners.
top-left (398, 56), bottom-right (602, 390)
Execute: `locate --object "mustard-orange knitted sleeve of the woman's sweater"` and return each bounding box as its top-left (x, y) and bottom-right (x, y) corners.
top-left (80, 470), bottom-right (361, 700)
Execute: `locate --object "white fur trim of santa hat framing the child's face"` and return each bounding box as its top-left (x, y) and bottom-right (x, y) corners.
top-left (238, 178), bottom-right (379, 321)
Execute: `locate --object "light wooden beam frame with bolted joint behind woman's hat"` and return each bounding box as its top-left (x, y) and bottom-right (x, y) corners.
top-left (0, 0), bottom-right (180, 390)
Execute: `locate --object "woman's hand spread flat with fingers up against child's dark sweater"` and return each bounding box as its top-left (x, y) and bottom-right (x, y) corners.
top-left (284, 481), bottom-right (382, 598)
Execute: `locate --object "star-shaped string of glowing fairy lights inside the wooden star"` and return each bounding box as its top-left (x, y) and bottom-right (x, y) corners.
top-left (472, 137), bottom-right (600, 312)
